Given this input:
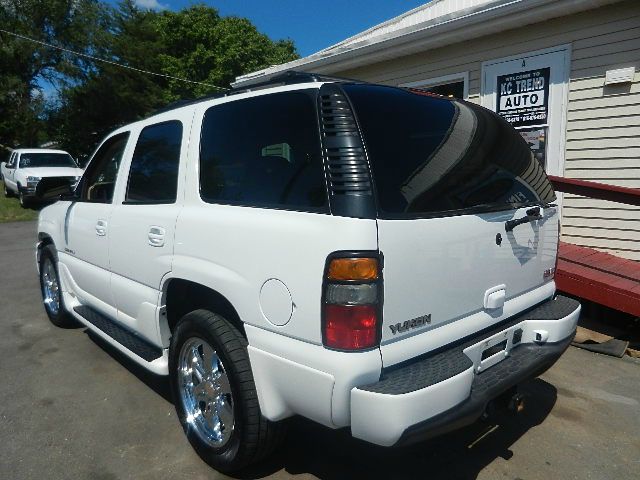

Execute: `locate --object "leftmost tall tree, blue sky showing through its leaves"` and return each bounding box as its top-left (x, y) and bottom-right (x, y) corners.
top-left (0, 0), bottom-right (100, 147)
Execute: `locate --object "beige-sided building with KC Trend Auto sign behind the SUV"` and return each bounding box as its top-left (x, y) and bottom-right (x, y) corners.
top-left (236, 0), bottom-right (640, 260)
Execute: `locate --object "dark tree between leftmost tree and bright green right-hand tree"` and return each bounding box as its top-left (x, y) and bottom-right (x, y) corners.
top-left (52, 0), bottom-right (168, 157)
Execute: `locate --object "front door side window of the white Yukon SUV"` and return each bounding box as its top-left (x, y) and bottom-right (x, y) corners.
top-left (81, 132), bottom-right (129, 203)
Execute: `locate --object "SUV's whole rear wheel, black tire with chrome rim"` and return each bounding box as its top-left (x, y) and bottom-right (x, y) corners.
top-left (169, 310), bottom-right (283, 472)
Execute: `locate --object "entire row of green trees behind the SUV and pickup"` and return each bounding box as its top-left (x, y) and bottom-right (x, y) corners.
top-left (0, 0), bottom-right (297, 156)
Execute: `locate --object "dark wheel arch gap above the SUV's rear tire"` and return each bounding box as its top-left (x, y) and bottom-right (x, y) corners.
top-left (160, 278), bottom-right (247, 345)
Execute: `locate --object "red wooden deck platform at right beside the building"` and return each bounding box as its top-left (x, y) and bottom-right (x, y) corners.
top-left (556, 242), bottom-right (640, 316)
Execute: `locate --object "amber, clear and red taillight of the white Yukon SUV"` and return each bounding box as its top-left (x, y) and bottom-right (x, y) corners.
top-left (322, 254), bottom-right (382, 350)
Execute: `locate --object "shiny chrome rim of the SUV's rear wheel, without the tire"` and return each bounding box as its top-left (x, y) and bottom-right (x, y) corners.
top-left (177, 337), bottom-right (235, 448)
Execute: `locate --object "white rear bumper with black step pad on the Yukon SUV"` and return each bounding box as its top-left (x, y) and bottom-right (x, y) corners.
top-left (351, 296), bottom-right (580, 446)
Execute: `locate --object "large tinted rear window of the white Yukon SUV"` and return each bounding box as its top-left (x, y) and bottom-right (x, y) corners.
top-left (344, 85), bottom-right (555, 217)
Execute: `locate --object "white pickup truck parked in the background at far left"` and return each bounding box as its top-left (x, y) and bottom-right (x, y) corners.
top-left (0, 148), bottom-right (83, 207)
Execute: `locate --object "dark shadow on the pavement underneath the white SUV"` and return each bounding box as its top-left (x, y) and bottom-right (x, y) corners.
top-left (85, 330), bottom-right (557, 480)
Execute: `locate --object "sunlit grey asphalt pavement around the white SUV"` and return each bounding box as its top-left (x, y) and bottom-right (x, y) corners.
top-left (0, 222), bottom-right (640, 480)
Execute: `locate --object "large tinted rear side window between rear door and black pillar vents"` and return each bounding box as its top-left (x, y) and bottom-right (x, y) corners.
top-left (200, 90), bottom-right (327, 210)
